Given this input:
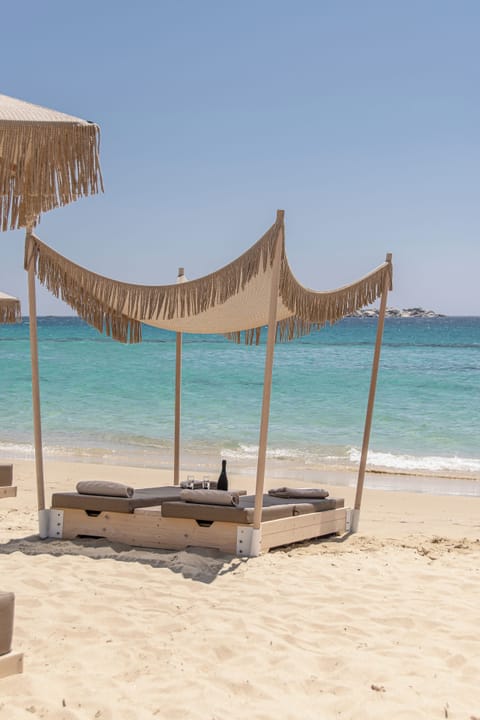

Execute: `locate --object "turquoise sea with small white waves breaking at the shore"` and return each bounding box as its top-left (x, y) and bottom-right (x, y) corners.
top-left (0, 317), bottom-right (480, 496)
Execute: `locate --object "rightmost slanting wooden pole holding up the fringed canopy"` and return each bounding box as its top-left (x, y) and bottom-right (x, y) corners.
top-left (351, 253), bottom-right (392, 533)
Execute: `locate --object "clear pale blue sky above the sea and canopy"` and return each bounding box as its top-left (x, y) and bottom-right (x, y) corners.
top-left (0, 0), bottom-right (480, 315)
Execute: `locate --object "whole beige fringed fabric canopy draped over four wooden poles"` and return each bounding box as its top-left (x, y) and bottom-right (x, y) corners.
top-left (25, 211), bottom-right (392, 344)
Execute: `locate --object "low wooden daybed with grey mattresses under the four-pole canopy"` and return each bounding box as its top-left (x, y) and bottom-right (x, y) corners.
top-left (48, 486), bottom-right (349, 556)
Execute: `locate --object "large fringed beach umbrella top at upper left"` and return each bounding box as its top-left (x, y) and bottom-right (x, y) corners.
top-left (0, 95), bottom-right (103, 230)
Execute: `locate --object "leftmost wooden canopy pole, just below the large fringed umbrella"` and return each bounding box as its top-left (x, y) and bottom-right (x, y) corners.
top-left (26, 227), bottom-right (49, 538)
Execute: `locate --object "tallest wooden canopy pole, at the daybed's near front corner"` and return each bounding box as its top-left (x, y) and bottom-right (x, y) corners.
top-left (253, 217), bottom-right (284, 532)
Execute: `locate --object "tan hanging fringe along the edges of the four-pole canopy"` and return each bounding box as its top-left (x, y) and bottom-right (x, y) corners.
top-left (20, 213), bottom-right (392, 345)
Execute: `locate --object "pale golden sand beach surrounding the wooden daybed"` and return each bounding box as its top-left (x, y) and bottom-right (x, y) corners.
top-left (0, 460), bottom-right (480, 720)
